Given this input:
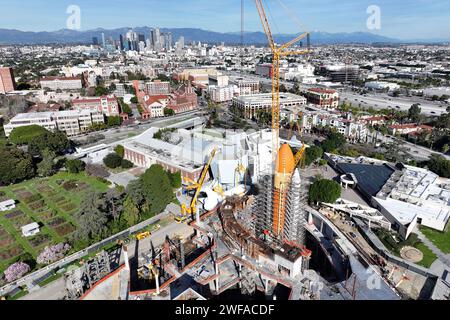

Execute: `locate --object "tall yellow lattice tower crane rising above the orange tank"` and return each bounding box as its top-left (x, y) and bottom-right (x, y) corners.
top-left (255, 0), bottom-right (310, 168)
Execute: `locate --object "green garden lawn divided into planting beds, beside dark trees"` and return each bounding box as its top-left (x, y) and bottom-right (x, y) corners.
top-left (0, 173), bottom-right (108, 273)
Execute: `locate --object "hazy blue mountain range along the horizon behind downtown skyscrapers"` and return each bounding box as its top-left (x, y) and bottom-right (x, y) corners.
top-left (0, 27), bottom-right (444, 45)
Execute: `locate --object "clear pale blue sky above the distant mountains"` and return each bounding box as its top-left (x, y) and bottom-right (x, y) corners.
top-left (0, 0), bottom-right (450, 39)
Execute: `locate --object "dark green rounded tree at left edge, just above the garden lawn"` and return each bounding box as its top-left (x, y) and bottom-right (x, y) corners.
top-left (0, 145), bottom-right (35, 185)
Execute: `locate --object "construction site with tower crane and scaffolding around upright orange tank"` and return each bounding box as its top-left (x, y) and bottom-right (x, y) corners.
top-left (53, 0), bottom-right (442, 300)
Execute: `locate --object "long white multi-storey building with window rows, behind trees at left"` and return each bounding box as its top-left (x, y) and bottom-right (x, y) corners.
top-left (4, 110), bottom-right (105, 137)
